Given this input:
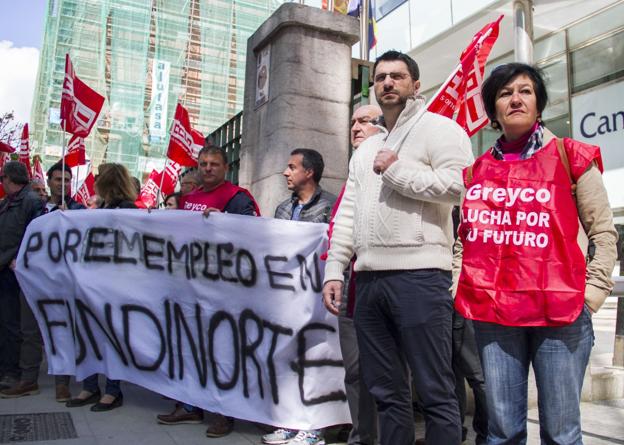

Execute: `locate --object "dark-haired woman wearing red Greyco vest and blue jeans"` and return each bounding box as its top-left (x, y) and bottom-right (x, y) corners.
top-left (454, 63), bottom-right (617, 445)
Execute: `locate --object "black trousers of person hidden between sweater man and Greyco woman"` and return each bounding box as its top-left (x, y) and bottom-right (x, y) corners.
top-left (453, 311), bottom-right (488, 445)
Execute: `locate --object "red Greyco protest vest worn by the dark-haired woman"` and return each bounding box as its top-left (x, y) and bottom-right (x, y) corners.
top-left (455, 139), bottom-right (602, 326)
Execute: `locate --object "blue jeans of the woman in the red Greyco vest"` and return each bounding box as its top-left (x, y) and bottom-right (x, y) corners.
top-left (474, 307), bottom-right (594, 445)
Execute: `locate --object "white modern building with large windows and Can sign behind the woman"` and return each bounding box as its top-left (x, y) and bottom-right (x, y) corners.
top-left (336, 0), bottom-right (624, 217)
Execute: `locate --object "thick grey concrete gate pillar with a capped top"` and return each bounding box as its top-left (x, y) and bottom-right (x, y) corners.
top-left (239, 3), bottom-right (359, 216)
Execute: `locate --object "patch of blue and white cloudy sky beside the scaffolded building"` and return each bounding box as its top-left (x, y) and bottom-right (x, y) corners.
top-left (0, 0), bottom-right (48, 123)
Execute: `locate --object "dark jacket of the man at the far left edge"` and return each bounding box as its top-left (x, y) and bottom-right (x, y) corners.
top-left (0, 185), bottom-right (44, 270)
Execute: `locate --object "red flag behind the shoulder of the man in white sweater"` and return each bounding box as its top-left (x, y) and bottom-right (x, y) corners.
top-left (427, 15), bottom-right (503, 136)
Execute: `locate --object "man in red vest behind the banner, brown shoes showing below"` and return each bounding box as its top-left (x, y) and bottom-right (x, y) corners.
top-left (156, 146), bottom-right (260, 437)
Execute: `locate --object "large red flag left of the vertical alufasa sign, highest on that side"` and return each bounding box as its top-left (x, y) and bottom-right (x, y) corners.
top-left (61, 54), bottom-right (104, 137)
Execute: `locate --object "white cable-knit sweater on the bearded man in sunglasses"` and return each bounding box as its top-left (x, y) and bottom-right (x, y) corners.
top-left (325, 96), bottom-right (473, 282)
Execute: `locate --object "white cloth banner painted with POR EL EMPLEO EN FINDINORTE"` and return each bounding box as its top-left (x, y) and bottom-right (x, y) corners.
top-left (16, 210), bottom-right (350, 429)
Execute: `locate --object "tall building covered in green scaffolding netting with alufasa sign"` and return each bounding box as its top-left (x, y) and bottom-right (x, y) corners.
top-left (31, 0), bottom-right (282, 177)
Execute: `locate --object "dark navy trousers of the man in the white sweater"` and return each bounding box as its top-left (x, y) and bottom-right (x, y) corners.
top-left (355, 269), bottom-right (461, 445)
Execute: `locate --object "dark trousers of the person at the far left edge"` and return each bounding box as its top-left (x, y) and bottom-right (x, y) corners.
top-left (0, 266), bottom-right (22, 379)
